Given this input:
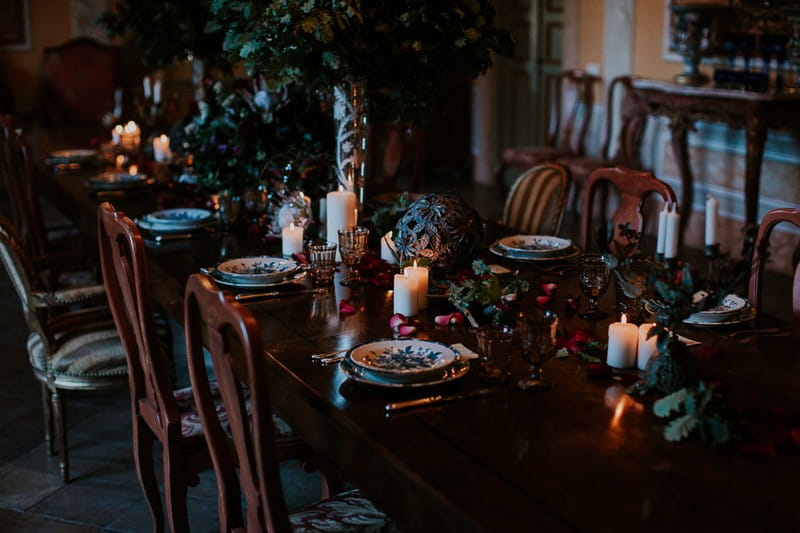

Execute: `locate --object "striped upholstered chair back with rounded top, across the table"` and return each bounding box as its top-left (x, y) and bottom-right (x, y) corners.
top-left (501, 163), bottom-right (572, 235)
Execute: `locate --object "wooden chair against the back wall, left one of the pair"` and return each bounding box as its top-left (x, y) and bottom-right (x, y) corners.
top-left (495, 69), bottom-right (600, 191)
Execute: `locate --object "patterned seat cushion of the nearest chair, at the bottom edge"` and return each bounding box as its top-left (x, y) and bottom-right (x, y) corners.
top-left (289, 490), bottom-right (398, 533)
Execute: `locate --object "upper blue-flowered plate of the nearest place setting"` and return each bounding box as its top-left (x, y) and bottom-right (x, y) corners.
top-left (347, 339), bottom-right (458, 375)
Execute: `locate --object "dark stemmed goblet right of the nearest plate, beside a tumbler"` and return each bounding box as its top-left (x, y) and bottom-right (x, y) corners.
top-left (516, 309), bottom-right (558, 390)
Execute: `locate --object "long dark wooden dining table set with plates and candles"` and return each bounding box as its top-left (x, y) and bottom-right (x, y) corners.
top-left (47, 169), bottom-right (800, 532)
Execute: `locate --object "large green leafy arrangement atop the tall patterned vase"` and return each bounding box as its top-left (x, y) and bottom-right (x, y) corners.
top-left (206, 0), bottom-right (513, 120)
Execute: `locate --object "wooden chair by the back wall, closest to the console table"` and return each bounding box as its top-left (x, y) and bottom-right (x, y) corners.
top-left (558, 75), bottom-right (647, 212)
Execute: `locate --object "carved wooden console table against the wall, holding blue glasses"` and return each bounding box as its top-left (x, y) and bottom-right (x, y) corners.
top-left (633, 79), bottom-right (800, 235)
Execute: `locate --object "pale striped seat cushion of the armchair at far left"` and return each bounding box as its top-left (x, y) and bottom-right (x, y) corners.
top-left (28, 327), bottom-right (128, 377)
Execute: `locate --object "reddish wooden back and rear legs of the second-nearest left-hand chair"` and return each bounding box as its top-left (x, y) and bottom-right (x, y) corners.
top-left (98, 202), bottom-right (203, 531)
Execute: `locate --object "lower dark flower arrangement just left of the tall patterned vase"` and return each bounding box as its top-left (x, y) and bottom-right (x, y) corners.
top-left (182, 80), bottom-right (332, 194)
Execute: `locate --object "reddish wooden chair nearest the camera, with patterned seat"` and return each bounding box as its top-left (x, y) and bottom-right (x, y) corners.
top-left (184, 274), bottom-right (394, 532)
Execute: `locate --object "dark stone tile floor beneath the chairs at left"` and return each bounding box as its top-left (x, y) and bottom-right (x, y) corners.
top-left (0, 264), bottom-right (320, 532)
